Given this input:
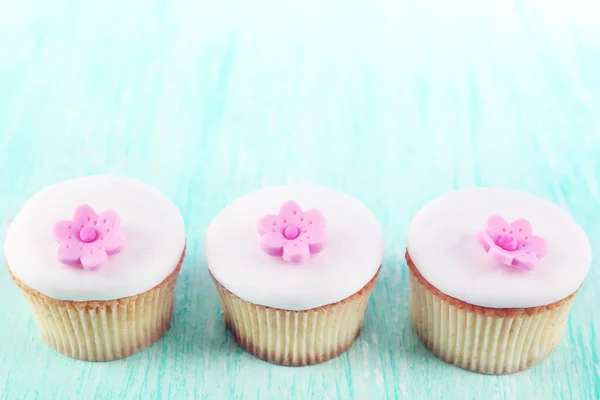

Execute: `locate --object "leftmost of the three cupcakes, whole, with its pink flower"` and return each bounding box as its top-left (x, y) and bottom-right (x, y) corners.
top-left (5, 176), bottom-right (185, 361)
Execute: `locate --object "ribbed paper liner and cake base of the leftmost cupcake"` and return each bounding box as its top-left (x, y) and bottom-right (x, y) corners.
top-left (11, 251), bottom-right (185, 361)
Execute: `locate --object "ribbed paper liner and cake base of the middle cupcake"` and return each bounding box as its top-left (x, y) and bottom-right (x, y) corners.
top-left (213, 271), bottom-right (379, 366)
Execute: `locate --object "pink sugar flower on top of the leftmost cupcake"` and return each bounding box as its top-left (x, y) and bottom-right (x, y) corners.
top-left (53, 204), bottom-right (125, 271)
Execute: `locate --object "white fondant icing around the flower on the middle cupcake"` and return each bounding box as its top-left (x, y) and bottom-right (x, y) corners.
top-left (204, 185), bottom-right (384, 310)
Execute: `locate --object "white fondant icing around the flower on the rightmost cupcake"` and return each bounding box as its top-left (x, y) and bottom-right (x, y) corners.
top-left (407, 189), bottom-right (592, 308)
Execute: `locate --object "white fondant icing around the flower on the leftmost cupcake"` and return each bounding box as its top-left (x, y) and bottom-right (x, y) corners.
top-left (5, 175), bottom-right (185, 301)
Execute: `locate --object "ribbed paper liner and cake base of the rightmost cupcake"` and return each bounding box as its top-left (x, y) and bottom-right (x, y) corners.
top-left (406, 254), bottom-right (575, 374)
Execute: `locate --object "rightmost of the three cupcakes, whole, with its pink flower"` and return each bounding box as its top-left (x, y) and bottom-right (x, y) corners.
top-left (406, 189), bottom-right (591, 374)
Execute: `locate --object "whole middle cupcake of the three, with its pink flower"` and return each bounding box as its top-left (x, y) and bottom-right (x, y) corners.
top-left (205, 185), bottom-right (384, 366)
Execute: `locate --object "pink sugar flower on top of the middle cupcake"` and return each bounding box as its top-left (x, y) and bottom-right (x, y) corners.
top-left (258, 201), bottom-right (328, 264)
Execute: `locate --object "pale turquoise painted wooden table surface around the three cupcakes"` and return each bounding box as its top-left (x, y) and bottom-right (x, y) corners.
top-left (0, 0), bottom-right (600, 400)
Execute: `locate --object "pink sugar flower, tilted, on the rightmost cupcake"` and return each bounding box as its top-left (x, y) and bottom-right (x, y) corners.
top-left (477, 215), bottom-right (547, 270)
